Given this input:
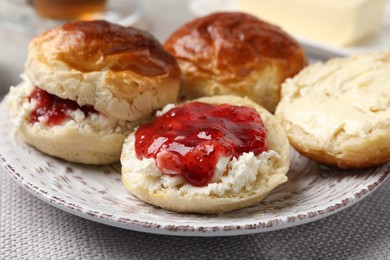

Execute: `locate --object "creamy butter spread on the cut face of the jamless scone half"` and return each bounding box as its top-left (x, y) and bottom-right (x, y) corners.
top-left (277, 51), bottom-right (390, 145)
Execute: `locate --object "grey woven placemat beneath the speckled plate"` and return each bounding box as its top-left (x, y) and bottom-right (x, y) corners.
top-left (0, 167), bottom-right (390, 259)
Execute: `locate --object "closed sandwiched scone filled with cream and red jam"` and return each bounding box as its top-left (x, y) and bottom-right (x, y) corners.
top-left (8, 21), bottom-right (180, 164)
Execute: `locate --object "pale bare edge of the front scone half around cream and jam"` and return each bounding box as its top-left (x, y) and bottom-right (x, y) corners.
top-left (121, 96), bottom-right (290, 213)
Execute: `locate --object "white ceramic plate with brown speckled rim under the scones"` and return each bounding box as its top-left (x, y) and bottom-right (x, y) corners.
top-left (0, 101), bottom-right (390, 236)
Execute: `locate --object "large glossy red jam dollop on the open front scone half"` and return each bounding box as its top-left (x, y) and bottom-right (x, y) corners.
top-left (135, 102), bottom-right (267, 187)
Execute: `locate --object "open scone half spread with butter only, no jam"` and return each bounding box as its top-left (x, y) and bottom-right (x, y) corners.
top-left (276, 51), bottom-right (390, 169)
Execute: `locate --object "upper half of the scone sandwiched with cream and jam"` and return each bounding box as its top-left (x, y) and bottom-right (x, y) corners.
top-left (25, 21), bottom-right (180, 121)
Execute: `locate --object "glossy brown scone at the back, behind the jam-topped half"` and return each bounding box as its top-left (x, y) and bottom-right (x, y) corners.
top-left (164, 12), bottom-right (306, 112)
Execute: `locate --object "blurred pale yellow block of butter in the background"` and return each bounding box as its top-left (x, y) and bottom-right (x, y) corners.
top-left (238, 0), bottom-right (385, 46)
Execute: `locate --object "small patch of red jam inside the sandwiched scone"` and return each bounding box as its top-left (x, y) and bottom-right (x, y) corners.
top-left (28, 87), bottom-right (98, 126)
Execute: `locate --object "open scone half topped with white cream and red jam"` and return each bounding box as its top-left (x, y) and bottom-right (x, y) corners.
top-left (121, 96), bottom-right (290, 213)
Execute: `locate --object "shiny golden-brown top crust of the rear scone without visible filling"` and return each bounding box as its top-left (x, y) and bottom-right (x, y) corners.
top-left (164, 12), bottom-right (306, 83)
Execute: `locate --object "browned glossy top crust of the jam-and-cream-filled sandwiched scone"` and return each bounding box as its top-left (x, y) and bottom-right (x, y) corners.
top-left (30, 21), bottom-right (179, 77)
